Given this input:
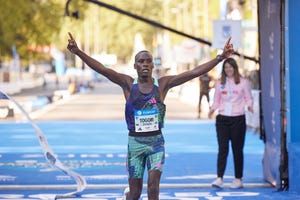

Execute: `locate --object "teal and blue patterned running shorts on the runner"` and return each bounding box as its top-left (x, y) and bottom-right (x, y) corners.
top-left (127, 134), bottom-right (165, 178)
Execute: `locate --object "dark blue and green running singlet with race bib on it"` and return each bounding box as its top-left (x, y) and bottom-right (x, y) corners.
top-left (125, 79), bottom-right (166, 136)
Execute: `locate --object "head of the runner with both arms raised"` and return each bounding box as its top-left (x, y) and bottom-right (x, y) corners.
top-left (134, 52), bottom-right (154, 77)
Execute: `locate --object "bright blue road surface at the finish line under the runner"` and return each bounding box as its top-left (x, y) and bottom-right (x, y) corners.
top-left (0, 120), bottom-right (300, 200)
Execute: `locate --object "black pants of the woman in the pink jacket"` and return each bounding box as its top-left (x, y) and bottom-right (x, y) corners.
top-left (216, 115), bottom-right (246, 178)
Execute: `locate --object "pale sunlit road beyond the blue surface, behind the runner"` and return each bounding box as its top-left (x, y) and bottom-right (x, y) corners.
top-left (8, 80), bottom-right (206, 121)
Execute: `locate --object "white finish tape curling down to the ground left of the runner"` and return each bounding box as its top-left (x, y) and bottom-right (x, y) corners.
top-left (0, 91), bottom-right (87, 199)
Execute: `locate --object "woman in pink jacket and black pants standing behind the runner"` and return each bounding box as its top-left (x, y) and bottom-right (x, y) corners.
top-left (209, 58), bottom-right (253, 188)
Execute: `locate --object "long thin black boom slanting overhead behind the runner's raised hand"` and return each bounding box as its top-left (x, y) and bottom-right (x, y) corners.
top-left (65, 0), bottom-right (258, 63)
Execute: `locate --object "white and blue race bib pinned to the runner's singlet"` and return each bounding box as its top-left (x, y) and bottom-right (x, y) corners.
top-left (134, 108), bottom-right (159, 132)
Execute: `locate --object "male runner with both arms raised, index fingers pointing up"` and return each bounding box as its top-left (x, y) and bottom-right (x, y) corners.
top-left (67, 33), bottom-right (234, 200)
